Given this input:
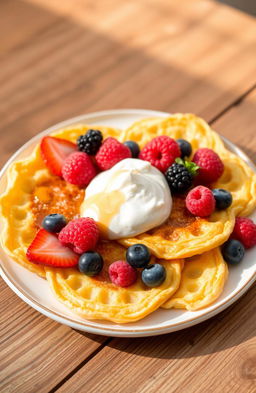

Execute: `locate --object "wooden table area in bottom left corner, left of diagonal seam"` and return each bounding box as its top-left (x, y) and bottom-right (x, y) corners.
top-left (0, 279), bottom-right (106, 393)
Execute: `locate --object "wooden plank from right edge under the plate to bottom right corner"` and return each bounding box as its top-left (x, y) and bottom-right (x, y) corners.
top-left (55, 89), bottom-right (256, 393)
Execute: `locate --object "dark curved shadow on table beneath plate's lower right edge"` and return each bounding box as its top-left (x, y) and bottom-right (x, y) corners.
top-left (76, 287), bottom-right (256, 359)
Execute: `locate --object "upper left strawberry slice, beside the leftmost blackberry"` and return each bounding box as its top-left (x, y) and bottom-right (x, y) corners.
top-left (40, 136), bottom-right (77, 176)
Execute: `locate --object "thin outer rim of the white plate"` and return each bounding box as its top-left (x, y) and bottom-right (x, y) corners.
top-left (0, 109), bottom-right (256, 337)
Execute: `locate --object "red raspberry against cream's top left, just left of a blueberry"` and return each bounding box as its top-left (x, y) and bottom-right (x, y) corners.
top-left (95, 137), bottom-right (132, 171)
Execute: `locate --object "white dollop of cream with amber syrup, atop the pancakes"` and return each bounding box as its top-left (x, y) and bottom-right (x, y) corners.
top-left (80, 158), bottom-right (172, 239)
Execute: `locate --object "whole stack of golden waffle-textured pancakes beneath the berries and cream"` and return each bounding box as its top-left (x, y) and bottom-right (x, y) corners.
top-left (0, 114), bottom-right (256, 323)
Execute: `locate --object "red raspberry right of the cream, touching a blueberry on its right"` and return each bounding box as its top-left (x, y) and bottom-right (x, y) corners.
top-left (186, 186), bottom-right (215, 217)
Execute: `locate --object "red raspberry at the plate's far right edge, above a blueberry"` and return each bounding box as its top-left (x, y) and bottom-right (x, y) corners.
top-left (231, 217), bottom-right (256, 248)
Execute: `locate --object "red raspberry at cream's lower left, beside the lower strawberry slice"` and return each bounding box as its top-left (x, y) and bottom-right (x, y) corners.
top-left (59, 217), bottom-right (99, 254)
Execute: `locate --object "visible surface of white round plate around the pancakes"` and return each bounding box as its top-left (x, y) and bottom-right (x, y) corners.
top-left (0, 109), bottom-right (256, 337)
